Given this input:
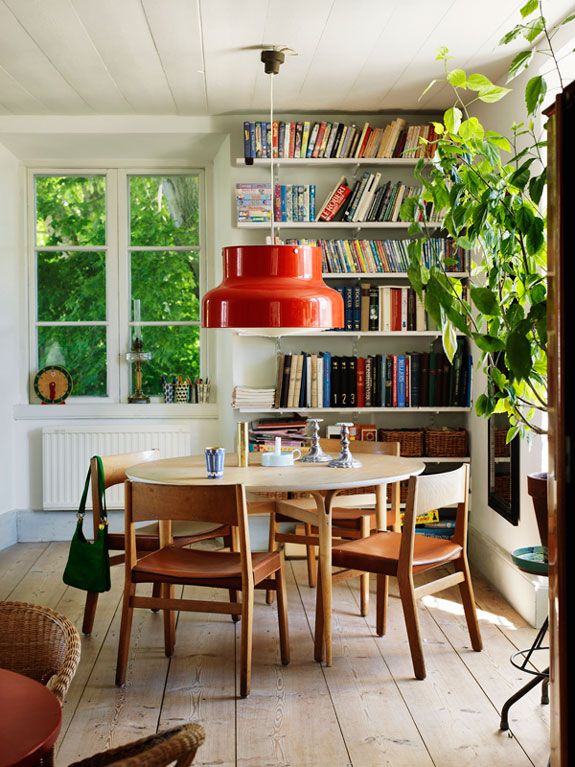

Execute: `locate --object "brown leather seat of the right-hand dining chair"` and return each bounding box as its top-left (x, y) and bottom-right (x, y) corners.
top-left (332, 533), bottom-right (461, 575)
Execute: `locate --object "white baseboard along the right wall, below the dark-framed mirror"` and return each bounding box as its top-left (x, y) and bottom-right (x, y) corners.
top-left (468, 527), bottom-right (549, 628)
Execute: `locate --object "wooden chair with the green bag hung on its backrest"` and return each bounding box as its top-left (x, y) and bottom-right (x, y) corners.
top-left (82, 450), bottom-right (230, 634)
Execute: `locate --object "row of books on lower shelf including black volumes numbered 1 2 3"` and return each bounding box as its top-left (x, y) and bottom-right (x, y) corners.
top-left (274, 343), bottom-right (472, 408)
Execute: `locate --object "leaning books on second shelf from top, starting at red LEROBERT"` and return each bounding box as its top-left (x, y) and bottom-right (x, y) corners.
top-left (316, 178), bottom-right (436, 222)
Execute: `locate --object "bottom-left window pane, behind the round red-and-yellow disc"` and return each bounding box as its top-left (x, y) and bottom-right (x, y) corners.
top-left (38, 327), bottom-right (107, 397)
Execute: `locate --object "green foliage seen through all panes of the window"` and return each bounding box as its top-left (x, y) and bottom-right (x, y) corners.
top-left (36, 175), bottom-right (200, 396)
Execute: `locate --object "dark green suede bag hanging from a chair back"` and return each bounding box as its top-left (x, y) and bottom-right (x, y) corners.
top-left (63, 456), bottom-right (111, 592)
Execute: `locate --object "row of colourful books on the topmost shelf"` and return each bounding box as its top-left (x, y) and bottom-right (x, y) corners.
top-left (244, 117), bottom-right (436, 160)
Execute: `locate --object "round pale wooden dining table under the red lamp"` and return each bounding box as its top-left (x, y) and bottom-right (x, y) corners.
top-left (126, 452), bottom-right (425, 666)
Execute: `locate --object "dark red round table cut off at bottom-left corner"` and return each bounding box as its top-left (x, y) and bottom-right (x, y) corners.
top-left (0, 668), bottom-right (62, 767)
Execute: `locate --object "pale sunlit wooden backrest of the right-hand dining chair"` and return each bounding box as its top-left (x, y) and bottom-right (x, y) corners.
top-left (400, 463), bottom-right (469, 560)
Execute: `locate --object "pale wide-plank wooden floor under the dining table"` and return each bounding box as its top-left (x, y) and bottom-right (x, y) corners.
top-left (0, 543), bottom-right (549, 767)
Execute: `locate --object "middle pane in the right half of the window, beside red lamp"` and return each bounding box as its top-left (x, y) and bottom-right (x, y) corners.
top-left (131, 251), bottom-right (200, 322)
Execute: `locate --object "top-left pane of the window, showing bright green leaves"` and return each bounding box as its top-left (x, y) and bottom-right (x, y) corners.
top-left (35, 176), bottom-right (106, 248)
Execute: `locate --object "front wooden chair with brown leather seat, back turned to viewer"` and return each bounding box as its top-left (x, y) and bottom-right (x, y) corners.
top-left (116, 482), bottom-right (289, 697)
